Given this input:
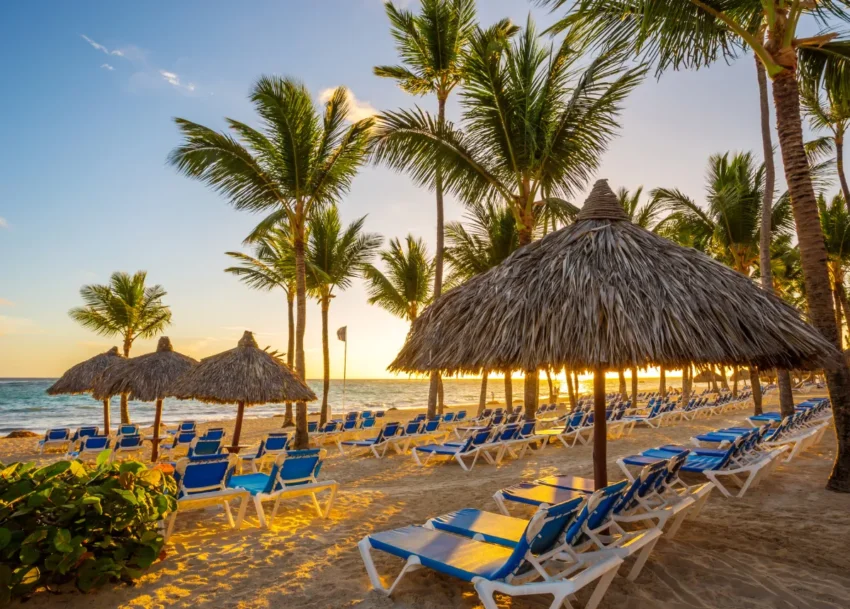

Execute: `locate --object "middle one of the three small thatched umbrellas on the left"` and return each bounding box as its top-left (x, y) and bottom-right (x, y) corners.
top-left (94, 336), bottom-right (198, 461)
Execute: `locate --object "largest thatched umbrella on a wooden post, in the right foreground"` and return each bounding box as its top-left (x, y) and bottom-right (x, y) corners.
top-left (390, 180), bottom-right (838, 485)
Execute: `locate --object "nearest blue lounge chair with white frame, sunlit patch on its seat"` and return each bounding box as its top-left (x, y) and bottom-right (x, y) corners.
top-left (358, 496), bottom-right (622, 609)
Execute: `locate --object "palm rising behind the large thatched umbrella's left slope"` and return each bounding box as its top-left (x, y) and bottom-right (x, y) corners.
top-left (446, 200), bottom-right (516, 413)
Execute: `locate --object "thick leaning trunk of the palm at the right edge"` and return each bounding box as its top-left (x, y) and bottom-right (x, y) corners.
top-left (773, 69), bottom-right (850, 492)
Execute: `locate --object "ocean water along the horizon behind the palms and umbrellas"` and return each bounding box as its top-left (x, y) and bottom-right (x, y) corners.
top-left (0, 378), bottom-right (658, 436)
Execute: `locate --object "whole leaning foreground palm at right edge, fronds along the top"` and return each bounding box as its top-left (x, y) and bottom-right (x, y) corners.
top-left (540, 0), bottom-right (850, 492)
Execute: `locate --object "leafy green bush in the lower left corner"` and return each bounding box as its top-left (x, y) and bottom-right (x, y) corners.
top-left (0, 452), bottom-right (177, 605)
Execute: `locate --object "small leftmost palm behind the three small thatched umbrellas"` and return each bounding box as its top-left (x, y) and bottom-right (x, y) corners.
top-left (68, 271), bottom-right (171, 424)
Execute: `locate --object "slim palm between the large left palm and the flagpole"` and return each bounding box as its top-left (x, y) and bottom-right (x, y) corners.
top-left (305, 205), bottom-right (381, 425)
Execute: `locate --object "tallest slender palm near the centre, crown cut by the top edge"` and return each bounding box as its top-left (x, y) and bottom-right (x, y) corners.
top-left (374, 0), bottom-right (475, 412)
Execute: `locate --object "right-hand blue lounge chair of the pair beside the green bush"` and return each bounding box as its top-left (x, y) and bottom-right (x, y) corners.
top-left (228, 448), bottom-right (339, 527)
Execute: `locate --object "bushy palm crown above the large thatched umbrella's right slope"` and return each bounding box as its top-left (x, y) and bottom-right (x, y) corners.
top-left (652, 152), bottom-right (794, 271)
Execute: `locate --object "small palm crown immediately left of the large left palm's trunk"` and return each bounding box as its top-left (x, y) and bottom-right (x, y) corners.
top-left (224, 225), bottom-right (295, 297)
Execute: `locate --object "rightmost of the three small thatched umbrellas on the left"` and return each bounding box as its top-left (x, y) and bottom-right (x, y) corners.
top-left (168, 332), bottom-right (316, 451)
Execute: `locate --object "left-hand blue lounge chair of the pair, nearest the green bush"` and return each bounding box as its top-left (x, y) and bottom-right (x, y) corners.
top-left (165, 455), bottom-right (250, 539)
